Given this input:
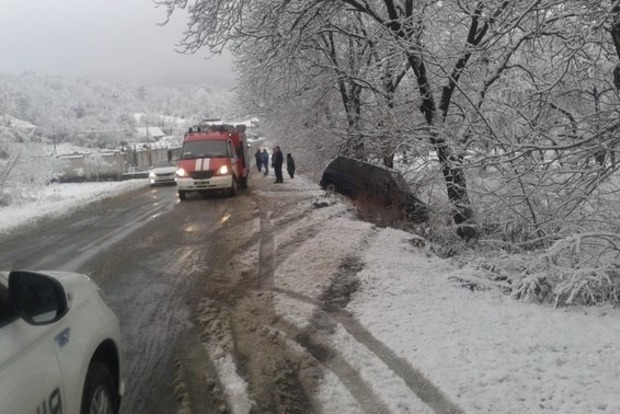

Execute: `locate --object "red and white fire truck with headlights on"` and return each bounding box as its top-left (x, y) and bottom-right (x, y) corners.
top-left (176, 123), bottom-right (250, 200)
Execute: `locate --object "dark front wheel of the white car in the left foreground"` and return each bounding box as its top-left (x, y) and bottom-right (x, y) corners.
top-left (80, 361), bottom-right (119, 414)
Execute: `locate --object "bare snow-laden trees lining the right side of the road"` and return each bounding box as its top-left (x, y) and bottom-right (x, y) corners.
top-left (155, 0), bottom-right (620, 304)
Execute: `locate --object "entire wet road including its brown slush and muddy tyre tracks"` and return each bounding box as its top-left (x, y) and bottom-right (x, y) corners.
top-left (0, 177), bottom-right (460, 413)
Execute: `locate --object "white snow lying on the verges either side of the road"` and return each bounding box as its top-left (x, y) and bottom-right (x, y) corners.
top-left (0, 177), bottom-right (620, 414)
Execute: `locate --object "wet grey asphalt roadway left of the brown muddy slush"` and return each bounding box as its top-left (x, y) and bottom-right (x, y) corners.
top-left (0, 186), bottom-right (240, 413)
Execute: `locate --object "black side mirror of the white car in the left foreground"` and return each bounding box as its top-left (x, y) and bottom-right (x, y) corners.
top-left (9, 271), bottom-right (69, 325)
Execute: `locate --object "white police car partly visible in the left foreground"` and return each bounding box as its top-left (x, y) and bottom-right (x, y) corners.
top-left (0, 271), bottom-right (123, 414)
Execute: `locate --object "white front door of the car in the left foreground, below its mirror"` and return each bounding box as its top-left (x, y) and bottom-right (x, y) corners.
top-left (0, 276), bottom-right (65, 414)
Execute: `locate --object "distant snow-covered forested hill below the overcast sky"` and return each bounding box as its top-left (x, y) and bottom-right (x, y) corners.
top-left (0, 72), bottom-right (234, 148)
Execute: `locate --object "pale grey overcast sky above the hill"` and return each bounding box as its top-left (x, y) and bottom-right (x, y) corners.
top-left (0, 0), bottom-right (234, 87)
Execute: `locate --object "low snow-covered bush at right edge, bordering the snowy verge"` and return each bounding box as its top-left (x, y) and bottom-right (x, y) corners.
top-left (454, 232), bottom-right (620, 306)
